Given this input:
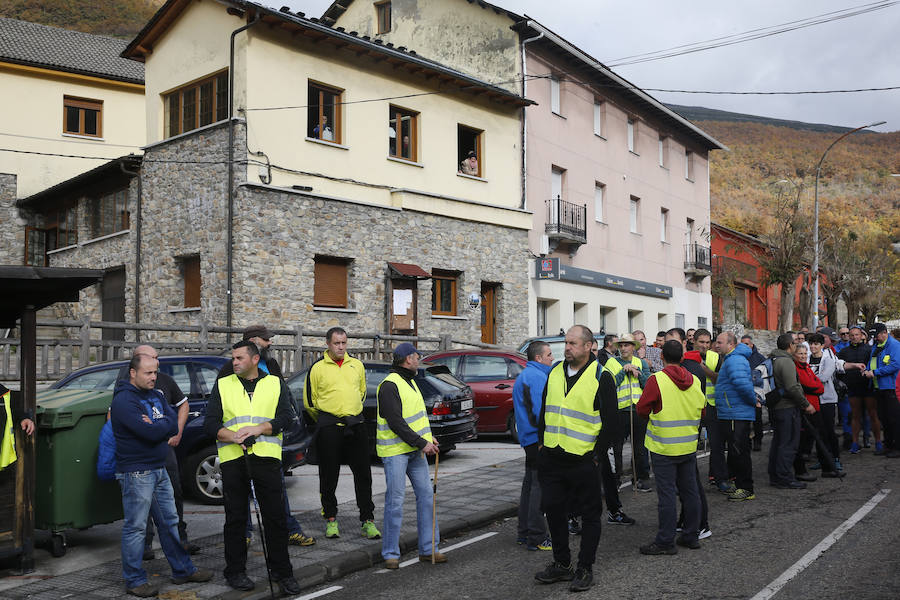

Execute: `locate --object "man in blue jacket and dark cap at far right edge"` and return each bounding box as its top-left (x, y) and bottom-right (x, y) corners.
top-left (863, 323), bottom-right (900, 458)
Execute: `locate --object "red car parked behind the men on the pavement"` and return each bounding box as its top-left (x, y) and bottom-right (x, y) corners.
top-left (424, 350), bottom-right (528, 441)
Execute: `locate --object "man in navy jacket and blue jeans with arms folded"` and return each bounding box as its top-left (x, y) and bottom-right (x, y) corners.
top-left (110, 354), bottom-right (212, 598)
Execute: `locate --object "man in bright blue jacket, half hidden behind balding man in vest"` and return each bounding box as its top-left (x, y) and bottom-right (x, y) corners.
top-left (513, 341), bottom-right (553, 550)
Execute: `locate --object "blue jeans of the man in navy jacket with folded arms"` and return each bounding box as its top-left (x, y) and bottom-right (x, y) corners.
top-left (116, 468), bottom-right (197, 589)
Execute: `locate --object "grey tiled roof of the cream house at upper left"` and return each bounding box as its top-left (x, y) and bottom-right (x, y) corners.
top-left (0, 17), bottom-right (144, 83)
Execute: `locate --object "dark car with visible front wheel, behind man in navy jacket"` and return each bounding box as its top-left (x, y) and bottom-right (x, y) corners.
top-left (47, 354), bottom-right (312, 504)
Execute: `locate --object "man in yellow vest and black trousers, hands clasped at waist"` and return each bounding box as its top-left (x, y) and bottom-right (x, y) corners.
top-left (203, 340), bottom-right (300, 594)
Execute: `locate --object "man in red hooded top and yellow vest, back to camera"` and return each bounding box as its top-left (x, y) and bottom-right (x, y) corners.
top-left (637, 337), bottom-right (706, 554)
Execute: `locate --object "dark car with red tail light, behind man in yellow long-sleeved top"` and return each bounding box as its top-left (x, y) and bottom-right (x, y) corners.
top-left (287, 361), bottom-right (478, 454)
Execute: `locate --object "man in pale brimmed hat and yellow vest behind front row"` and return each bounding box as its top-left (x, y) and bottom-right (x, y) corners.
top-left (603, 333), bottom-right (651, 492)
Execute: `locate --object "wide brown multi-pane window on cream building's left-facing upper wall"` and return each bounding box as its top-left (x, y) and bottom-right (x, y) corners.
top-left (163, 71), bottom-right (228, 137)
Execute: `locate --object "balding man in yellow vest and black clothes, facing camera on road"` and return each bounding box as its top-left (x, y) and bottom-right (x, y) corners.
top-left (534, 325), bottom-right (618, 592)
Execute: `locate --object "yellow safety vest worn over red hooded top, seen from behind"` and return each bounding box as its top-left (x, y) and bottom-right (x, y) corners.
top-left (644, 371), bottom-right (706, 456)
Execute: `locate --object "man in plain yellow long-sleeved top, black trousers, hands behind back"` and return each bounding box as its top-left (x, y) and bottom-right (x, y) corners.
top-left (304, 327), bottom-right (381, 540)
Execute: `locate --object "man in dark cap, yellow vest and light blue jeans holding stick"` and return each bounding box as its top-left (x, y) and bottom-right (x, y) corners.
top-left (375, 342), bottom-right (447, 569)
